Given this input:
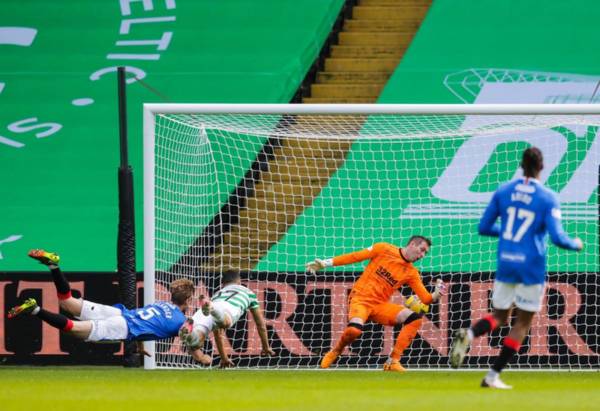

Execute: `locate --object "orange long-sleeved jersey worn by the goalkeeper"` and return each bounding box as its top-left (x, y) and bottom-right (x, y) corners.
top-left (333, 243), bottom-right (432, 304)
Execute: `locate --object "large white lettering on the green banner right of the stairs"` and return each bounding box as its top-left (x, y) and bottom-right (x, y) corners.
top-left (401, 73), bottom-right (600, 221)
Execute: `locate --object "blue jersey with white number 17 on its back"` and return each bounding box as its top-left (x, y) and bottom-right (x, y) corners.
top-left (479, 178), bottom-right (578, 285)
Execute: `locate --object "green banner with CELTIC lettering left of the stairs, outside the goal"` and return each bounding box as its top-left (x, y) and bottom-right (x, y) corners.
top-left (0, 0), bottom-right (342, 271)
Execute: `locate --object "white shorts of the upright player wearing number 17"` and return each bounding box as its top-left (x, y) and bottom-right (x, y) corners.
top-left (492, 280), bottom-right (546, 313)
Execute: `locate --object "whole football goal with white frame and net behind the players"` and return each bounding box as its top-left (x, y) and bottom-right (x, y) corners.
top-left (144, 104), bottom-right (600, 369)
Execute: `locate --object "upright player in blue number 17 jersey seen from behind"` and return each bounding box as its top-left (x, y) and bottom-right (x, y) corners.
top-left (450, 147), bottom-right (583, 389)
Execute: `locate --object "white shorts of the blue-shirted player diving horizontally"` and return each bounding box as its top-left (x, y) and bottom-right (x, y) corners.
top-left (76, 300), bottom-right (129, 342)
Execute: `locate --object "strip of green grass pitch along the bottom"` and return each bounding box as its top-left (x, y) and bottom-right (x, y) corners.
top-left (0, 367), bottom-right (600, 411)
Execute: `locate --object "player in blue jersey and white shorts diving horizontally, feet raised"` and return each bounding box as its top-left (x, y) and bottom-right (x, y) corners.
top-left (8, 250), bottom-right (195, 355)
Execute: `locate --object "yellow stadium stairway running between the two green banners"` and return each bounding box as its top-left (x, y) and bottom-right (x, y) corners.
top-left (200, 0), bottom-right (431, 271)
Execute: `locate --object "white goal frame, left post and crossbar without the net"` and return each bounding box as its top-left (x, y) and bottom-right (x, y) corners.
top-left (143, 103), bottom-right (600, 371)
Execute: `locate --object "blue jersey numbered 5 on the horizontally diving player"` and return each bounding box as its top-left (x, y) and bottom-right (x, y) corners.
top-left (115, 301), bottom-right (185, 341)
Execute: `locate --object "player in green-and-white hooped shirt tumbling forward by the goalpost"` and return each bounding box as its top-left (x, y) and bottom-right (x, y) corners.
top-left (179, 271), bottom-right (275, 368)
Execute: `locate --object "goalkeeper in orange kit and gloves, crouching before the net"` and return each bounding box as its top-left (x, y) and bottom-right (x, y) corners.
top-left (306, 235), bottom-right (445, 372)
